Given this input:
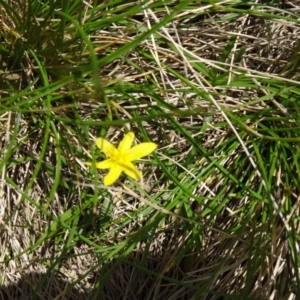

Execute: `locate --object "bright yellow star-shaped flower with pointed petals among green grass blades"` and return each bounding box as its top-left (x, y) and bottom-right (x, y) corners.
top-left (87, 132), bottom-right (157, 185)
